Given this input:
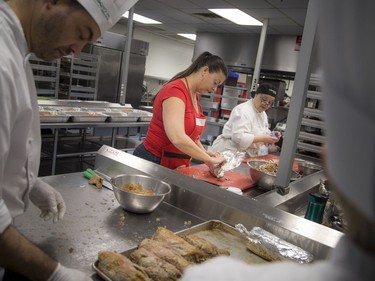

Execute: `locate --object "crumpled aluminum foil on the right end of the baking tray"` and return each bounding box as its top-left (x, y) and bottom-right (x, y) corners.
top-left (235, 224), bottom-right (314, 263)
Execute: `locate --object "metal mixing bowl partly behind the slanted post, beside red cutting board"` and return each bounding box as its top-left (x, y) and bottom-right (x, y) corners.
top-left (247, 160), bottom-right (301, 190)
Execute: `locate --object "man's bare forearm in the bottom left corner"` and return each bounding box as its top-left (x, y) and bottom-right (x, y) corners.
top-left (0, 225), bottom-right (57, 280)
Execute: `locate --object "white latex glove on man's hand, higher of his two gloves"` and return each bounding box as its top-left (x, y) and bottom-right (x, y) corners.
top-left (30, 179), bottom-right (66, 222)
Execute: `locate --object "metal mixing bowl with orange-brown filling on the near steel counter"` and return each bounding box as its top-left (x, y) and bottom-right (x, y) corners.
top-left (111, 175), bottom-right (171, 214)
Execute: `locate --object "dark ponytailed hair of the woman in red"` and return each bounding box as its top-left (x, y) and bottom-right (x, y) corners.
top-left (168, 52), bottom-right (228, 82)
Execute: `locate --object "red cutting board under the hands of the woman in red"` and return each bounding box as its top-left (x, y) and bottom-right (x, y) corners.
top-left (176, 164), bottom-right (255, 190)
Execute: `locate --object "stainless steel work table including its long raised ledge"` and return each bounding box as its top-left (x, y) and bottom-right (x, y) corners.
top-left (15, 151), bottom-right (342, 278)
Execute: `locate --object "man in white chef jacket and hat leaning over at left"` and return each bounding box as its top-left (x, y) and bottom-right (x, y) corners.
top-left (0, 0), bottom-right (137, 281)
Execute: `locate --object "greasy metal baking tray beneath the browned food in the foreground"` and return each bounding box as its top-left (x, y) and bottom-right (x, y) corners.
top-left (92, 220), bottom-right (268, 281)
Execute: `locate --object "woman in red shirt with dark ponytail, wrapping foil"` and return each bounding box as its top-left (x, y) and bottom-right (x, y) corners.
top-left (133, 52), bottom-right (227, 169)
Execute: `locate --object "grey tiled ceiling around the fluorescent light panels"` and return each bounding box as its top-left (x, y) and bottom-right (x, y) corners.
top-left (122, 0), bottom-right (308, 41)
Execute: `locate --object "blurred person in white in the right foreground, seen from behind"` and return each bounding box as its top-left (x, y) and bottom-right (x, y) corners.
top-left (182, 0), bottom-right (375, 281)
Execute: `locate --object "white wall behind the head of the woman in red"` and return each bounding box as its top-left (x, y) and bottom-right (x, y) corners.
top-left (110, 24), bottom-right (194, 80)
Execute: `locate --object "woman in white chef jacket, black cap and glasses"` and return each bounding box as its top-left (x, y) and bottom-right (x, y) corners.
top-left (209, 83), bottom-right (281, 157)
